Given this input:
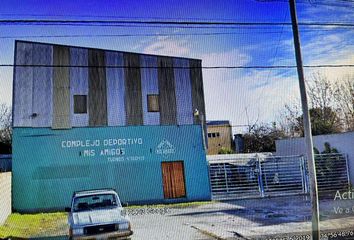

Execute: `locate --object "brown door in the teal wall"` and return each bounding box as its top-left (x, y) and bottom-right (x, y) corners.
top-left (161, 161), bottom-right (186, 198)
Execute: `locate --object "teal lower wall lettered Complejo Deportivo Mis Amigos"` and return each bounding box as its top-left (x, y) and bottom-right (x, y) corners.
top-left (13, 125), bottom-right (210, 211)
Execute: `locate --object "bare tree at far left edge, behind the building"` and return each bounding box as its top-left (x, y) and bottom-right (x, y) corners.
top-left (0, 104), bottom-right (12, 154)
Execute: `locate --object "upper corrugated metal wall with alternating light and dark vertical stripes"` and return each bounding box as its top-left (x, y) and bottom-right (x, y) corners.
top-left (13, 41), bottom-right (205, 129)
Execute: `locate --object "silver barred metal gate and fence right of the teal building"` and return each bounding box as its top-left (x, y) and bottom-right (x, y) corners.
top-left (207, 154), bottom-right (349, 200)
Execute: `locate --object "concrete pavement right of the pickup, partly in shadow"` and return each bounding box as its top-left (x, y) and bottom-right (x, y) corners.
top-left (131, 196), bottom-right (354, 239)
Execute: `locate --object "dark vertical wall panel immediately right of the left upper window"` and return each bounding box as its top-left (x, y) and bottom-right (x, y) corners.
top-left (88, 49), bottom-right (107, 126)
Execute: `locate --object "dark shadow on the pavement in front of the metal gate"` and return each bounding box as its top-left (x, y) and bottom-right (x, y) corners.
top-left (170, 195), bottom-right (354, 226)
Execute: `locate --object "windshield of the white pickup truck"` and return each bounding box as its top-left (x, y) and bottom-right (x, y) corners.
top-left (73, 194), bottom-right (121, 212)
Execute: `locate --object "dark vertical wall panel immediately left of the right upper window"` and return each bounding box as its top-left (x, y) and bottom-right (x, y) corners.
top-left (123, 53), bottom-right (143, 125)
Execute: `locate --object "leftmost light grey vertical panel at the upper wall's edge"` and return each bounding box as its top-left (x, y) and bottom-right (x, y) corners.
top-left (13, 42), bottom-right (33, 127)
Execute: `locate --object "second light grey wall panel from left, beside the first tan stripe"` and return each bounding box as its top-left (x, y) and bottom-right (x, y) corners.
top-left (32, 44), bottom-right (53, 127)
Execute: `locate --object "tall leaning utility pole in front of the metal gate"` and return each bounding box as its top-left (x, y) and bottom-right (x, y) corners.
top-left (289, 0), bottom-right (320, 240)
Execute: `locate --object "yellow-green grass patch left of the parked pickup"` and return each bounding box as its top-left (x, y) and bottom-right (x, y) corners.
top-left (0, 212), bottom-right (68, 238)
